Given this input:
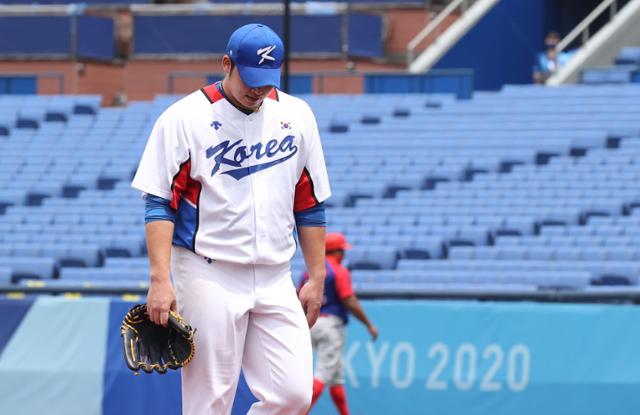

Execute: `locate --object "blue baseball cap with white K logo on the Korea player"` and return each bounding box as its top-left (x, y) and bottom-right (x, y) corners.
top-left (226, 23), bottom-right (284, 88)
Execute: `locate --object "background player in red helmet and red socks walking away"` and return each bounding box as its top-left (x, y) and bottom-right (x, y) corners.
top-left (301, 233), bottom-right (378, 415)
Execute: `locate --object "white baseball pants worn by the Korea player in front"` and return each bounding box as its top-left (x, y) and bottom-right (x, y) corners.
top-left (171, 247), bottom-right (313, 415)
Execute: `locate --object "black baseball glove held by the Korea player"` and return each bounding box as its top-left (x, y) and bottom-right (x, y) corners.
top-left (120, 304), bottom-right (196, 375)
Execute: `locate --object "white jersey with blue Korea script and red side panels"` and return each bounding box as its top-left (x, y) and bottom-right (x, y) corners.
top-left (132, 84), bottom-right (331, 264)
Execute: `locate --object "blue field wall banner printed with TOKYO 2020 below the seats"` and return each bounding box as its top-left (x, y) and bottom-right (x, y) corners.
top-left (0, 297), bottom-right (640, 415)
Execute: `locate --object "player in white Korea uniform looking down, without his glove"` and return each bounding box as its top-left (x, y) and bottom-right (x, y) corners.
top-left (132, 24), bottom-right (331, 415)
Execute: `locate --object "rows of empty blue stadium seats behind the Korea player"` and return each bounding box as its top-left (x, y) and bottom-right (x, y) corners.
top-left (0, 85), bottom-right (640, 292)
